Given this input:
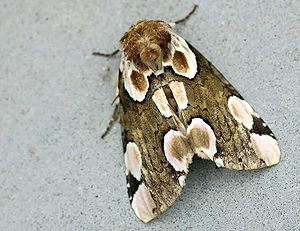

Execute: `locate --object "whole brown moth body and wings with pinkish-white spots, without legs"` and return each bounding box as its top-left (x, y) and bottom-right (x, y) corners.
top-left (96, 7), bottom-right (280, 223)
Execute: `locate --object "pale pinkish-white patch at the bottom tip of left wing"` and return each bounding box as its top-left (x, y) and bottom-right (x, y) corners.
top-left (131, 183), bottom-right (156, 223)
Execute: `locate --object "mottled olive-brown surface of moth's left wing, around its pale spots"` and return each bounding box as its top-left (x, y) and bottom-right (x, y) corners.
top-left (119, 69), bottom-right (186, 222)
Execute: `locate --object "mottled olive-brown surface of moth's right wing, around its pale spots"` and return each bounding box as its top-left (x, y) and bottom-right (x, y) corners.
top-left (179, 46), bottom-right (279, 170)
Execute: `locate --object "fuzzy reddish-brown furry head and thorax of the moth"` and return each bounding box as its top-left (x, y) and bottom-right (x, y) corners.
top-left (120, 19), bottom-right (171, 75)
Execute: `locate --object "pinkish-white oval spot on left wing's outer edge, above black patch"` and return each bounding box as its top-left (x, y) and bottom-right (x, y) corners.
top-left (125, 142), bottom-right (142, 181)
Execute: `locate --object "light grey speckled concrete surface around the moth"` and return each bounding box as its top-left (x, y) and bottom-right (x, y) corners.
top-left (0, 0), bottom-right (300, 231)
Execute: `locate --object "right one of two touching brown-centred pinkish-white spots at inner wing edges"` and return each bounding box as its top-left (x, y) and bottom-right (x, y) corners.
top-left (187, 118), bottom-right (217, 160)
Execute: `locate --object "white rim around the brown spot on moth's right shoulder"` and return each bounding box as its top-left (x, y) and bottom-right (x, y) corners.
top-left (163, 33), bottom-right (197, 79)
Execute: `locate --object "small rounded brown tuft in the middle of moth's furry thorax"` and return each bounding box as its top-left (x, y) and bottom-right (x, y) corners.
top-left (140, 43), bottom-right (163, 75)
